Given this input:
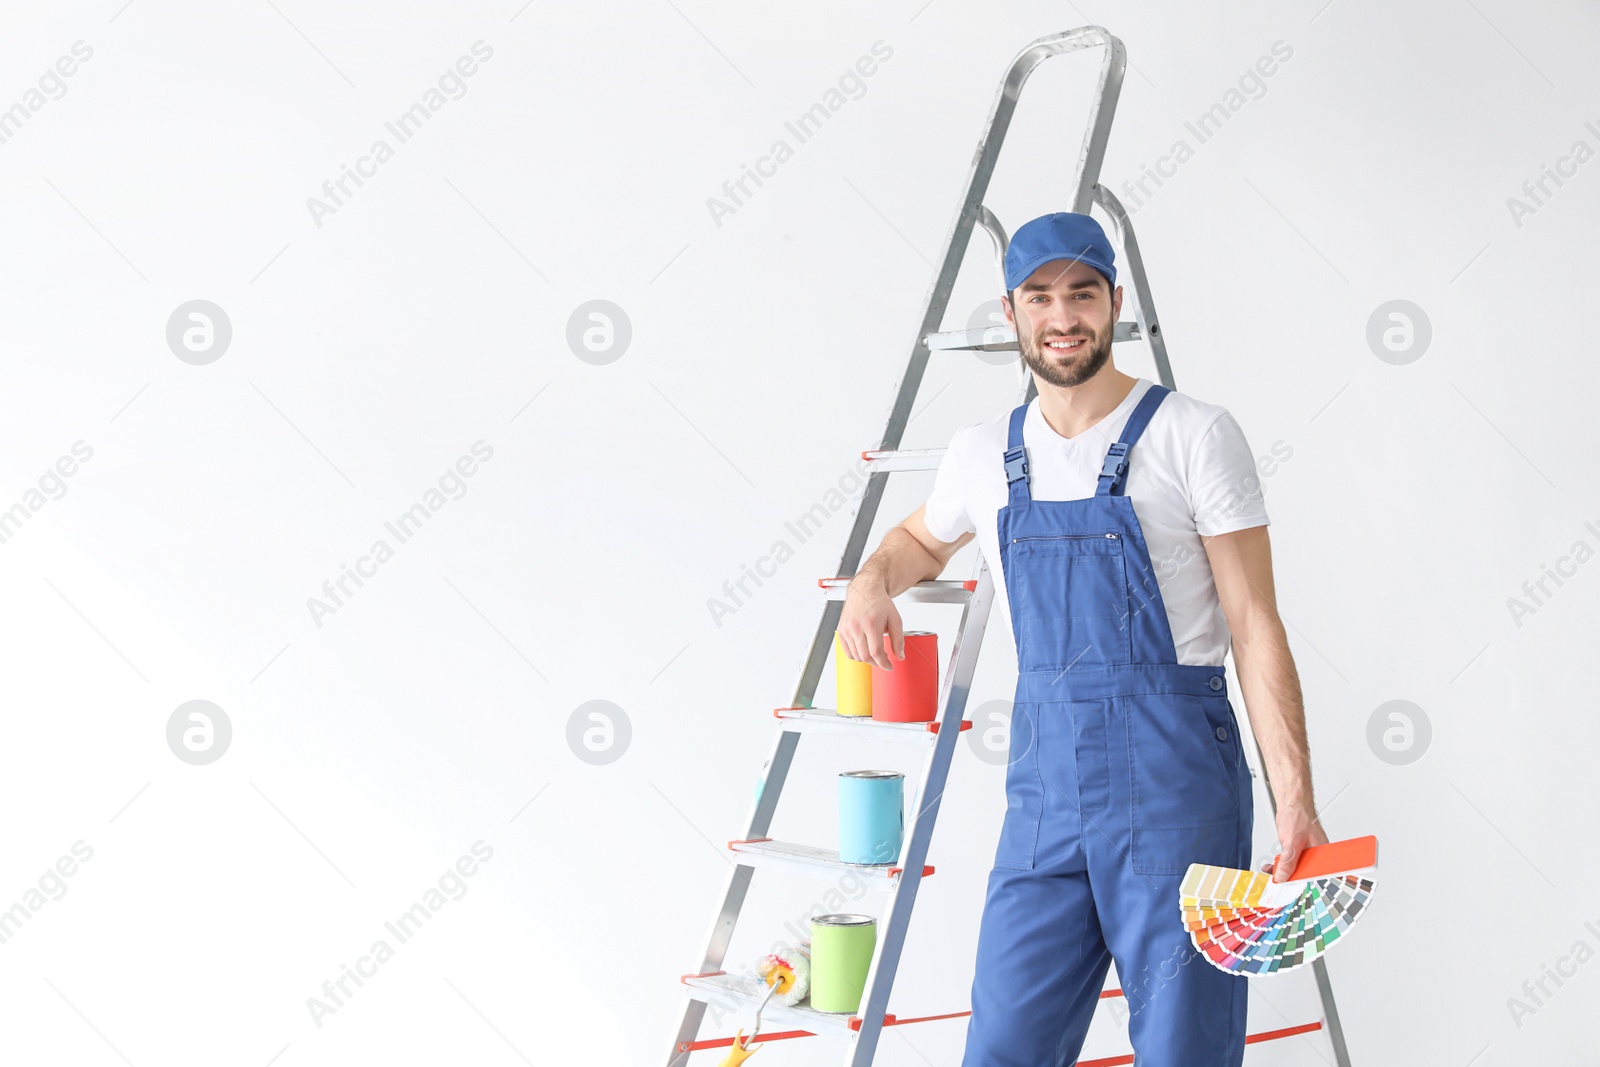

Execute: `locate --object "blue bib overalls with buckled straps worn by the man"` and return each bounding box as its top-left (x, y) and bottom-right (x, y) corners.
top-left (962, 384), bottom-right (1254, 1067)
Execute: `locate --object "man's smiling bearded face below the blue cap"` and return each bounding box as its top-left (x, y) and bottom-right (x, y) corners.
top-left (1006, 259), bottom-right (1122, 389)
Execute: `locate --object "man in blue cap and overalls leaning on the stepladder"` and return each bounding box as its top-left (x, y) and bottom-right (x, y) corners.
top-left (838, 211), bottom-right (1328, 1067)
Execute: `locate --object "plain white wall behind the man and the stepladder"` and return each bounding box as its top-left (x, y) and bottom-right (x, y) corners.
top-left (0, 0), bottom-right (1600, 1067)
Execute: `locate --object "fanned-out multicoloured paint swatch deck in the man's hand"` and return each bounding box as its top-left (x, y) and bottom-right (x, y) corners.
top-left (1178, 835), bottom-right (1378, 977)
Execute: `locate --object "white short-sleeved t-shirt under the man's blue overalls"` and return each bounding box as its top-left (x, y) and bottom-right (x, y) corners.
top-left (923, 378), bottom-right (1267, 667)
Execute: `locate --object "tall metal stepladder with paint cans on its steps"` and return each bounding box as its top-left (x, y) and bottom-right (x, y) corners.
top-left (667, 26), bottom-right (1350, 1067)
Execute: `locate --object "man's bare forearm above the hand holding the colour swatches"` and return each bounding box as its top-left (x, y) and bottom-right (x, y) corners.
top-left (1234, 611), bottom-right (1314, 809)
